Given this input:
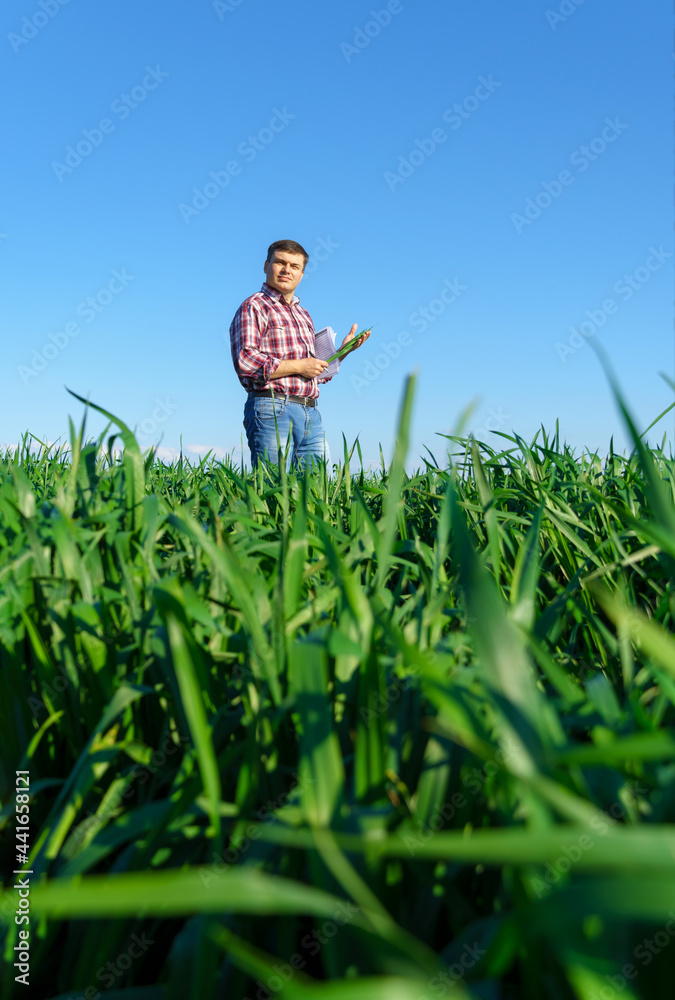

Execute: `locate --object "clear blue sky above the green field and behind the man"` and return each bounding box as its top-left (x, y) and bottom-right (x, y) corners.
top-left (0, 0), bottom-right (675, 468)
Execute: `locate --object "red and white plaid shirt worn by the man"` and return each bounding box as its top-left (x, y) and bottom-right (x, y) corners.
top-left (230, 283), bottom-right (332, 399)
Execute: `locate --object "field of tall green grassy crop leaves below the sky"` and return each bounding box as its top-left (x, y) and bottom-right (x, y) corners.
top-left (0, 380), bottom-right (675, 1000)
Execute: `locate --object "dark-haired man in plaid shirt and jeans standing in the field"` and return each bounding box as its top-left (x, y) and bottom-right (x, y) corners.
top-left (230, 240), bottom-right (370, 468)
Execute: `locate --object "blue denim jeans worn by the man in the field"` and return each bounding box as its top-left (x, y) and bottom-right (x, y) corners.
top-left (244, 395), bottom-right (330, 469)
